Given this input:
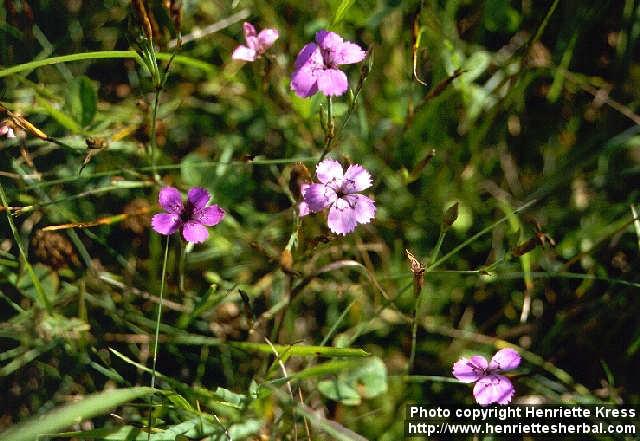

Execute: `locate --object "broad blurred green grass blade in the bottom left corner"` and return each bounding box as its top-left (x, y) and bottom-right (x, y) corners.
top-left (0, 387), bottom-right (154, 441)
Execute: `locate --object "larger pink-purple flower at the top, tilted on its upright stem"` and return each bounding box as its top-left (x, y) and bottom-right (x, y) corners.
top-left (291, 30), bottom-right (367, 98)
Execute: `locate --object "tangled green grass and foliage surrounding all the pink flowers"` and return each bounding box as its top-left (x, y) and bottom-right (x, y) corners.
top-left (0, 0), bottom-right (640, 441)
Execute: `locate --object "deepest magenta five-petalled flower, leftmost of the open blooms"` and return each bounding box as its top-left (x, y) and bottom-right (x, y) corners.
top-left (151, 187), bottom-right (224, 243)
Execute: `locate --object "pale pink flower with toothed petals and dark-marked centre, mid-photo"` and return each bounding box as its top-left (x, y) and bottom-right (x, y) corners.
top-left (298, 159), bottom-right (376, 235)
